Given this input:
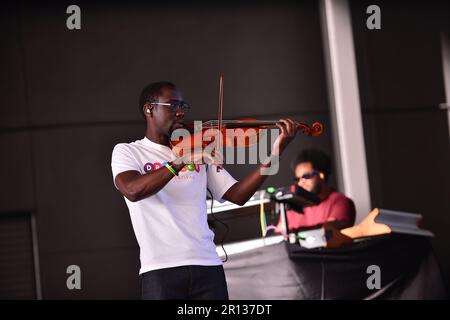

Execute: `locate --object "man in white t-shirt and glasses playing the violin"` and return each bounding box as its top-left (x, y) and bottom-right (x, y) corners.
top-left (111, 82), bottom-right (298, 299)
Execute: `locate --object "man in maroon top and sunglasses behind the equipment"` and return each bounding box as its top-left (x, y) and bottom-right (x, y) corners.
top-left (277, 149), bottom-right (356, 231)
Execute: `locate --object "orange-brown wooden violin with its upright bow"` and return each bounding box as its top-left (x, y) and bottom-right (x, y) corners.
top-left (172, 75), bottom-right (323, 156)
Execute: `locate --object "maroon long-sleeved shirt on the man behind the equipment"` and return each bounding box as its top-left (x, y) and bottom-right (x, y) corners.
top-left (277, 190), bottom-right (356, 230)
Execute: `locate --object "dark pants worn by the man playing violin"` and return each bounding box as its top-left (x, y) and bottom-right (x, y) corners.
top-left (141, 266), bottom-right (228, 300)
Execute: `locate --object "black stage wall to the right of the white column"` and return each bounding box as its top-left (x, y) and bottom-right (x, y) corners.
top-left (351, 1), bottom-right (450, 286)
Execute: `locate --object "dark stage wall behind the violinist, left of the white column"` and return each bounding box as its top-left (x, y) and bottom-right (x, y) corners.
top-left (0, 2), bottom-right (332, 299)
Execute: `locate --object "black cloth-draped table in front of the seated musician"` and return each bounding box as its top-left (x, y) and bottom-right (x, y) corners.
top-left (224, 234), bottom-right (447, 300)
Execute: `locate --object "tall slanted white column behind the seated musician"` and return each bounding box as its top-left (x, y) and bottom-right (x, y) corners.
top-left (320, 0), bottom-right (371, 222)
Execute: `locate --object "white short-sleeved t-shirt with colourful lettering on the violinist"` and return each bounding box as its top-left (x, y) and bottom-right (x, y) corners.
top-left (111, 137), bottom-right (237, 274)
